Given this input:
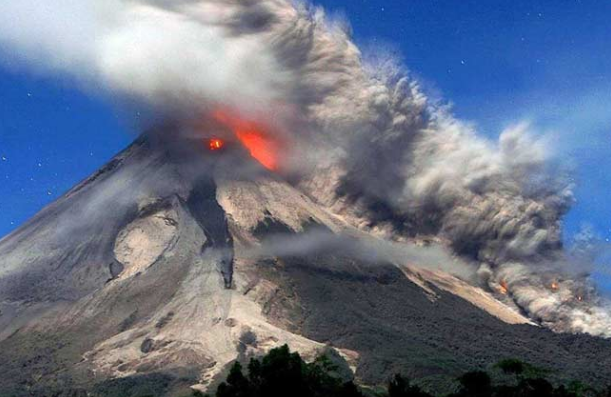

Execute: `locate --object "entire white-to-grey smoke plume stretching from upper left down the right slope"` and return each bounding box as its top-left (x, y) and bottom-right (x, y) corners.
top-left (0, 0), bottom-right (611, 336)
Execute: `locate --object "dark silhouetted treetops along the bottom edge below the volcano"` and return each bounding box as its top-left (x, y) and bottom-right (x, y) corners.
top-left (194, 345), bottom-right (611, 397)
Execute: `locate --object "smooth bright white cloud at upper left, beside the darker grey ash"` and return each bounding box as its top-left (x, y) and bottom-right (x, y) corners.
top-left (0, 0), bottom-right (288, 115)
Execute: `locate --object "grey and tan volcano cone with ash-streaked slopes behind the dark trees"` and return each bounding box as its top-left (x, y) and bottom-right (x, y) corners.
top-left (0, 133), bottom-right (611, 397)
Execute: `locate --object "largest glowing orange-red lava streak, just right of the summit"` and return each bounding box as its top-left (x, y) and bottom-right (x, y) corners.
top-left (213, 110), bottom-right (279, 171)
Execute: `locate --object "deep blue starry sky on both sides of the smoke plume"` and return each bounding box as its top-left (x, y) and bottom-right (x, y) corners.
top-left (0, 0), bottom-right (611, 249)
